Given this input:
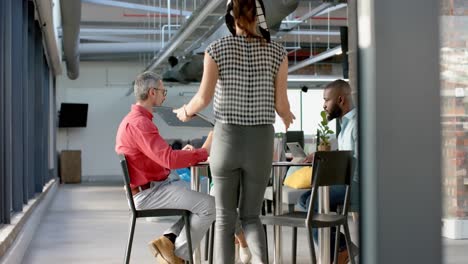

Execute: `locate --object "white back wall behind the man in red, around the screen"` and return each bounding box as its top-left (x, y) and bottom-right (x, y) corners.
top-left (57, 62), bottom-right (209, 180)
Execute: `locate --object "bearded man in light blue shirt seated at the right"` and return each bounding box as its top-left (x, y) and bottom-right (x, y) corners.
top-left (299, 80), bottom-right (359, 263)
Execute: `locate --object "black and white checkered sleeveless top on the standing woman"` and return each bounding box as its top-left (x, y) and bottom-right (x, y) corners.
top-left (206, 36), bottom-right (286, 126)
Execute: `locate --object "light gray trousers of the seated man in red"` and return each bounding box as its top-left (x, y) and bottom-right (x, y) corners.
top-left (133, 178), bottom-right (215, 260)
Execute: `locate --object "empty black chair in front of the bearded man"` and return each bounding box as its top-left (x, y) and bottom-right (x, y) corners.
top-left (261, 151), bottom-right (354, 264)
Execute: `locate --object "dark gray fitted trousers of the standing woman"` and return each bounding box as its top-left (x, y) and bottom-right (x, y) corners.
top-left (210, 122), bottom-right (274, 264)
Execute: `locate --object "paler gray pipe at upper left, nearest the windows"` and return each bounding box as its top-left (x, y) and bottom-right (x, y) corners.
top-left (34, 0), bottom-right (62, 76)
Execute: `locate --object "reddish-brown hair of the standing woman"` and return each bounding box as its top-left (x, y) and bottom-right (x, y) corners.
top-left (232, 0), bottom-right (264, 39)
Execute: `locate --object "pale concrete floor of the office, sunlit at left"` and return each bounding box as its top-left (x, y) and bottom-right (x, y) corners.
top-left (23, 183), bottom-right (468, 264)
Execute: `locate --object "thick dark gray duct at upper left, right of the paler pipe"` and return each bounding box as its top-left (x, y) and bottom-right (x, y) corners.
top-left (60, 0), bottom-right (81, 80)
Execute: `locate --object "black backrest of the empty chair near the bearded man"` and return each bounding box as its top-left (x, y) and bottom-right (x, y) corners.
top-left (307, 151), bottom-right (353, 221)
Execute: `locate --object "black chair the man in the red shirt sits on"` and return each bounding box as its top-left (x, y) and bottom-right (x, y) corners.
top-left (119, 155), bottom-right (193, 264)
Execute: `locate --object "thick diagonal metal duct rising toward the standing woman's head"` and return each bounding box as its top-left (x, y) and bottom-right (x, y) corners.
top-left (145, 0), bottom-right (225, 71)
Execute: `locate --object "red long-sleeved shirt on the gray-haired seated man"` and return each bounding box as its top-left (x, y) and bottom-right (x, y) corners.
top-left (115, 105), bottom-right (208, 188)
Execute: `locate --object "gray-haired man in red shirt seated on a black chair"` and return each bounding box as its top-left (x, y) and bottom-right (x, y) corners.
top-left (115, 72), bottom-right (215, 264)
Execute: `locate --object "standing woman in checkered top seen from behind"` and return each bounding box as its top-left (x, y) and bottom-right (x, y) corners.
top-left (174, 0), bottom-right (295, 264)
